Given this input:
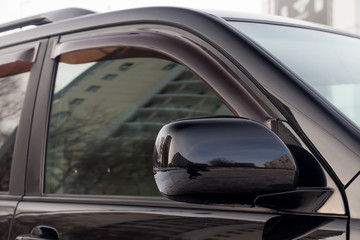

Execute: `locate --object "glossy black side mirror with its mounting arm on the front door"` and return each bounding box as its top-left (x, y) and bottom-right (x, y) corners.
top-left (153, 117), bottom-right (331, 211)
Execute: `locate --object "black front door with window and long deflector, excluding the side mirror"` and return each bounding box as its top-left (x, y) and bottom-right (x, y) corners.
top-left (10, 25), bottom-right (347, 239)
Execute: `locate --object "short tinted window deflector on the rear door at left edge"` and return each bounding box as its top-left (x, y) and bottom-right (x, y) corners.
top-left (0, 44), bottom-right (38, 77)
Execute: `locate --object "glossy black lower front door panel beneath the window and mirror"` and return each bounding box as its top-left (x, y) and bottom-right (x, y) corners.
top-left (11, 202), bottom-right (346, 240)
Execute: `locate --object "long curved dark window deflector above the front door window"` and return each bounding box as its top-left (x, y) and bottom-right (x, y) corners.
top-left (51, 31), bottom-right (272, 127)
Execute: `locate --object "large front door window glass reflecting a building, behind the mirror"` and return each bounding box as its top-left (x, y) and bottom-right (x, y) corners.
top-left (45, 48), bottom-right (232, 195)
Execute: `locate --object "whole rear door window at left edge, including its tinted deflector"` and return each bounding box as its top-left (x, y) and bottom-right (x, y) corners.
top-left (0, 48), bottom-right (35, 191)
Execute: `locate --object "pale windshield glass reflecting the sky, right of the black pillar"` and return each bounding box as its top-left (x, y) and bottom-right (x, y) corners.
top-left (231, 22), bottom-right (360, 126)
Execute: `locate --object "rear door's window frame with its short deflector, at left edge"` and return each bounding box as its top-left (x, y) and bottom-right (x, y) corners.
top-left (0, 39), bottom-right (47, 199)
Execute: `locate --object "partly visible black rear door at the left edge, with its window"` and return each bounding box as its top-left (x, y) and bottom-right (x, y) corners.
top-left (0, 41), bottom-right (46, 239)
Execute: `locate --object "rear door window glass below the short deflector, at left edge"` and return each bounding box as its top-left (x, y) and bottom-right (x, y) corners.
top-left (0, 73), bottom-right (29, 191)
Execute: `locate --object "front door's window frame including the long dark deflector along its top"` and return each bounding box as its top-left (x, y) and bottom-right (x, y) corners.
top-left (26, 25), bottom-right (271, 202)
